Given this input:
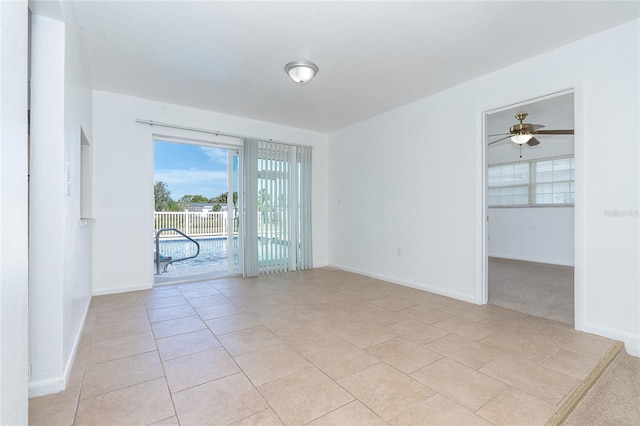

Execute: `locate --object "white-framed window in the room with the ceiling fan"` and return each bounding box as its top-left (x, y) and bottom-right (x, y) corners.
top-left (487, 157), bottom-right (575, 207)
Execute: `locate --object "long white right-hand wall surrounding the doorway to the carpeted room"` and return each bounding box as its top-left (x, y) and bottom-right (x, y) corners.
top-left (328, 20), bottom-right (640, 355)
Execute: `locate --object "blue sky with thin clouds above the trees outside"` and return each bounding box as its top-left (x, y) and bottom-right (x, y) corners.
top-left (154, 140), bottom-right (237, 201)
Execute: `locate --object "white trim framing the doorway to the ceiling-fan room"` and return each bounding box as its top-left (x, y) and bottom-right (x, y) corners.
top-left (475, 81), bottom-right (586, 330)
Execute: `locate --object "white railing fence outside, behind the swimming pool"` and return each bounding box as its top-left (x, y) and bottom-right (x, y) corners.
top-left (153, 212), bottom-right (238, 238)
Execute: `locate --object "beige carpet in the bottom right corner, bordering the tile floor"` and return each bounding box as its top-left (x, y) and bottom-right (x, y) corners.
top-left (563, 350), bottom-right (640, 426)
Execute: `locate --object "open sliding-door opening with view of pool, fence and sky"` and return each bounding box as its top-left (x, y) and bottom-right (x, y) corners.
top-left (153, 137), bottom-right (242, 284)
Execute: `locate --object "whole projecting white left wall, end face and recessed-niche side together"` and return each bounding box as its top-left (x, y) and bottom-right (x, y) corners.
top-left (29, 8), bottom-right (92, 396)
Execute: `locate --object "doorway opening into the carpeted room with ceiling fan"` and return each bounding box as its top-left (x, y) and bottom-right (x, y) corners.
top-left (484, 92), bottom-right (575, 325)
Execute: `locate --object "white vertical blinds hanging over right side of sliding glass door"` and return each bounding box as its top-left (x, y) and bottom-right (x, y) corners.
top-left (242, 139), bottom-right (312, 277)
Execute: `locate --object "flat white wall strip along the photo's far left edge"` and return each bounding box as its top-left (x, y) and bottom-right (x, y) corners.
top-left (0, 1), bottom-right (28, 425)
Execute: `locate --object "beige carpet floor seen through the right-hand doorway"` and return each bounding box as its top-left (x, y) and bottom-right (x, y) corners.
top-left (489, 257), bottom-right (574, 324)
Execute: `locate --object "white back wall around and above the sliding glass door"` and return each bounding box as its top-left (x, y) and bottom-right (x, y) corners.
top-left (93, 91), bottom-right (328, 294)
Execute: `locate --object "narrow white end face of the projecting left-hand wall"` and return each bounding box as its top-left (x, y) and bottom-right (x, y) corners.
top-left (28, 10), bottom-right (69, 395)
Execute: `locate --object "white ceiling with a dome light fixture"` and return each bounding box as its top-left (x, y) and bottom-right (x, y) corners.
top-left (43, 1), bottom-right (640, 133)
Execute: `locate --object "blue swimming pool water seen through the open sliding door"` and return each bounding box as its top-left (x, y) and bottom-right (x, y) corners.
top-left (160, 237), bottom-right (238, 279)
